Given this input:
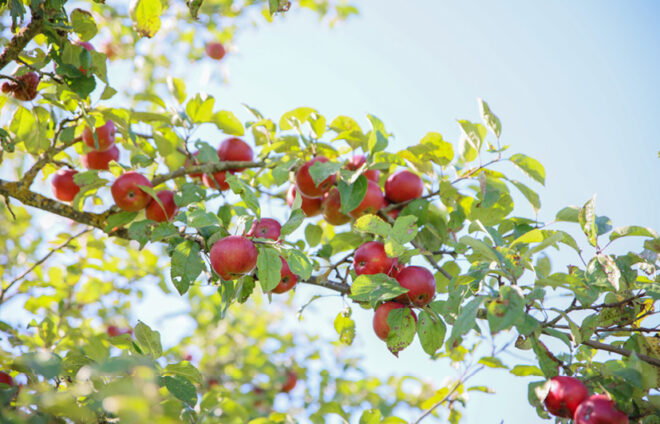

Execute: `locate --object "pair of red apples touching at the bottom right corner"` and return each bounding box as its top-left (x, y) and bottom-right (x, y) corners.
top-left (544, 376), bottom-right (628, 424)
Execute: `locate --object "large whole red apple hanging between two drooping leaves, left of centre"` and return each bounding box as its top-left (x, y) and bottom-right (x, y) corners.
top-left (210, 236), bottom-right (258, 280)
